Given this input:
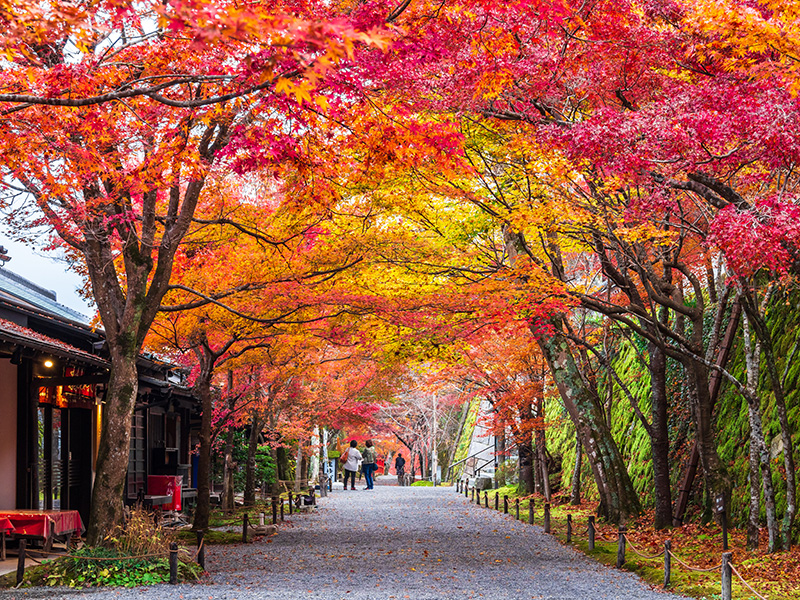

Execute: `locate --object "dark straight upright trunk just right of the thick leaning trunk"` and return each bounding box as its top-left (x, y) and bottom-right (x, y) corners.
top-left (649, 344), bottom-right (672, 529)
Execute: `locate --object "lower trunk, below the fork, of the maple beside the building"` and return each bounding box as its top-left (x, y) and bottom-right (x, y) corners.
top-left (86, 353), bottom-right (139, 546)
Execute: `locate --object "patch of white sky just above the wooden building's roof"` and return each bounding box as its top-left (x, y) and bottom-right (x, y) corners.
top-left (0, 237), bottom-right (95, 317)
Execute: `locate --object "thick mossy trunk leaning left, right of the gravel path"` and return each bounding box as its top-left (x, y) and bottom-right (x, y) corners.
top-left (532, 317), bottom-right (642, 523)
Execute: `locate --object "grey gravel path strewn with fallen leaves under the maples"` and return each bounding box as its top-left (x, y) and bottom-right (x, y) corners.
top-left (0, 485), bottom-right (692, 600)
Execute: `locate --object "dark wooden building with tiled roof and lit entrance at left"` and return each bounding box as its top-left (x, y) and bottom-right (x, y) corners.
top-left (0, 268), bottom-right (199, 522)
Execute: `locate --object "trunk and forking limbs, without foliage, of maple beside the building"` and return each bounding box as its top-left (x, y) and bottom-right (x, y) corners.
top-left (80, 123), bottom-right (228, 545)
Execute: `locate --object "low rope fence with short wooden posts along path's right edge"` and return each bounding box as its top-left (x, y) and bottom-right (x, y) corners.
top-left (456, 480), bottom-right (769, 600)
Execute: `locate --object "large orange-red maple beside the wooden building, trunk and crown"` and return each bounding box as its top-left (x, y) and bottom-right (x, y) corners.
top-left (0, 1), bottom-right (396, 544)
